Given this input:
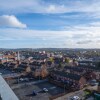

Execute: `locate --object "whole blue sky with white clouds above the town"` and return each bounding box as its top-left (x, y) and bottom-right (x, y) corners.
top-left (0, 0), bottom-right (100, 48)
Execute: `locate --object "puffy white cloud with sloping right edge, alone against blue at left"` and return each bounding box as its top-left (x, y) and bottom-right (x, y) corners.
top-left (0, 15), bottom-right (27, 28)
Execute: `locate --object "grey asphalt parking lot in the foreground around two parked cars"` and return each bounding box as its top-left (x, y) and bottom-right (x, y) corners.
top-left (14, 82), bottom-right (64, 100)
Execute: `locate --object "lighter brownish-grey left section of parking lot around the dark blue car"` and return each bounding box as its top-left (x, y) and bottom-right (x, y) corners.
top-left (13, 82), bottom-right (49, 100)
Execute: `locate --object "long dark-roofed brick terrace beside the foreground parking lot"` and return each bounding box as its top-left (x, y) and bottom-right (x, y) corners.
top-left (49, 70), bottom-right (86, 90)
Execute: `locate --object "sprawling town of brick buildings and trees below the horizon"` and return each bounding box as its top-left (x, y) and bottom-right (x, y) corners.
top-left (0, 48), bottom-right (100, 100)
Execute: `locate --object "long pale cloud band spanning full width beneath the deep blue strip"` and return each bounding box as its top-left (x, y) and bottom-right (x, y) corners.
top-left (0, 19), bottom-right (100, 41)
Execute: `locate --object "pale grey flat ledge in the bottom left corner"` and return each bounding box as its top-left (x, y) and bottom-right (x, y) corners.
top-left (0, 75), bottom-right (19, 100)
